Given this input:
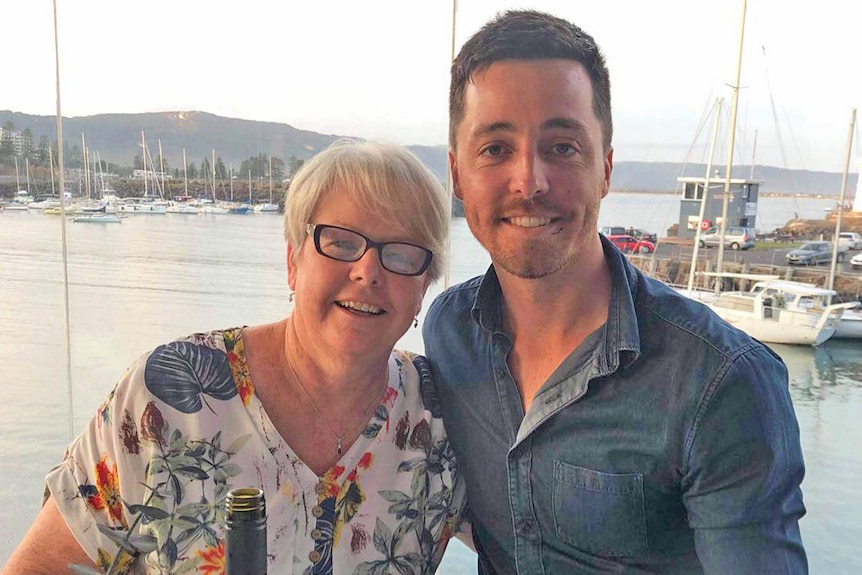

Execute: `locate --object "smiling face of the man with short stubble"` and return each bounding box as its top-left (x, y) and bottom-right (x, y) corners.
top-left (449, 60), bottom-right (613, 278)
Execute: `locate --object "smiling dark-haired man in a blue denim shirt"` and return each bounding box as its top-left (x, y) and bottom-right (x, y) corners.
top-left (423, 11), bottom-right (807, 575)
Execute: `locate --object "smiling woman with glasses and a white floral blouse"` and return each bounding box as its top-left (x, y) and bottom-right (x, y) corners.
top-left (5, 142), bottom-right (463, 575)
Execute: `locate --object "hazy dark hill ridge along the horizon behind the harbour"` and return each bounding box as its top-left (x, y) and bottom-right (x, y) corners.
top-left (0, 110), bottom-right (856, 196)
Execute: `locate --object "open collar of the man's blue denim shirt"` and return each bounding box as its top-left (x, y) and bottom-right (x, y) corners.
top-left (470, 236), bottom-right (640, 375)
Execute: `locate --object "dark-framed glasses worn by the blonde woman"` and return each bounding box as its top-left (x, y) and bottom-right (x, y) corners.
top-left (306, 224), bottom-right (434, 276)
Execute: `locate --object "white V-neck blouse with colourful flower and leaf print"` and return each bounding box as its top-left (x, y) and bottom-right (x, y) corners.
top-left (46, 328), bottom-right (465, 575)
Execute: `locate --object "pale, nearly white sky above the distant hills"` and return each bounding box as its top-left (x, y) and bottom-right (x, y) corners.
top-left (6, 0), bottom-right (862, 172)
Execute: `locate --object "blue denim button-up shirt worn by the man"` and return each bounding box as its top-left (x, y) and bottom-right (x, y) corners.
top-left (423, 240), bottom-right (807, 575)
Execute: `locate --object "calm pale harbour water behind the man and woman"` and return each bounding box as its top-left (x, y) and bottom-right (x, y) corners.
top-left (0, 194), bottom-right (862, 574)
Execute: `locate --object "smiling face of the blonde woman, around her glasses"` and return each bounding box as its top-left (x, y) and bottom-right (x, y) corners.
top-left (287, 189), bottom-right (428, 360)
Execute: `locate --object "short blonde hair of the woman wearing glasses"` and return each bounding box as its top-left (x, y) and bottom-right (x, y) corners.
top-left (284, 140), bottom-right (449, 282)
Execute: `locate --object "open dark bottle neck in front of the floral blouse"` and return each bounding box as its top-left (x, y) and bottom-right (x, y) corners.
top-left (225, 487), bottom-right (266, 575)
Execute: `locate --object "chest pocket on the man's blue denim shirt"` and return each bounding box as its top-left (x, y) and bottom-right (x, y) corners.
top-left (553, 460), bottom-right (647, 557)
